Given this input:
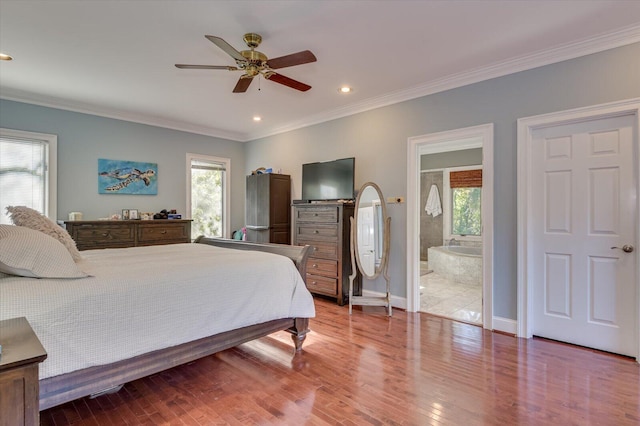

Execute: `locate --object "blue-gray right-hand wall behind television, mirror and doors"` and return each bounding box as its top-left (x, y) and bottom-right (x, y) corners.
top-left (246, 43), bottom-right (640, 319)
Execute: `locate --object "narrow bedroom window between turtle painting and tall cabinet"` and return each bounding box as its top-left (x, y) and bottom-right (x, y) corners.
top-left (187, 154), bottom-right (231, 238)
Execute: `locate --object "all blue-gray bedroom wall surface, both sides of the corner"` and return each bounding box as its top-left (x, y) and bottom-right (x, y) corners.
top-left (0, 43), bottom-right (640, 319)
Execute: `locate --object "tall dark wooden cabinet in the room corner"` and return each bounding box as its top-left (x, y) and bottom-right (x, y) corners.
top-left (245, 173), bottom-right (291, 244)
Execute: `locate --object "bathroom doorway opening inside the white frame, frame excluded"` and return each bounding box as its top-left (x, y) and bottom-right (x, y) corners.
top-left (419, 162), bottom-right (482, 325)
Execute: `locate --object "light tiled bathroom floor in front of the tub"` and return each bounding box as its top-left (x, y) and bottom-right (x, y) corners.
top-left (420, 262), bottom-right (482, 325)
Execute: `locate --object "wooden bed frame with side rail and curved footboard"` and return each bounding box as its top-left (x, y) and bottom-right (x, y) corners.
top-left (40, 237), bottom-right (310, 410)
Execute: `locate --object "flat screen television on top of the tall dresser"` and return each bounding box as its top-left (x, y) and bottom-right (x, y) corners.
top-left (302, 158), bottom-right (356, 201)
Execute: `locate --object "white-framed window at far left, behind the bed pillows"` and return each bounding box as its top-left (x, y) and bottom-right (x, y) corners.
top-left (0, 129), bottom-right (58, 224)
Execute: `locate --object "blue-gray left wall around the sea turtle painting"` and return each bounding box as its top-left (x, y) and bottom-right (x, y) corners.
top-left (0, 100), bottom-right (245, 235)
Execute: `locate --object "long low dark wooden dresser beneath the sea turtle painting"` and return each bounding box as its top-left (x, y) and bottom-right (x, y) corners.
top-left (65, 219), bottom-right (191, 250)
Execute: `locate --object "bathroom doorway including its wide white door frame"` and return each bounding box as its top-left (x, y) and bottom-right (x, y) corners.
top-left (407, 124), bottom-right (493, 329)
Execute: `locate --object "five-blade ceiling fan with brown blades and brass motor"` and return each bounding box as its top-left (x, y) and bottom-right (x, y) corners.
top-left (176, 33), bottom-right (316, 93)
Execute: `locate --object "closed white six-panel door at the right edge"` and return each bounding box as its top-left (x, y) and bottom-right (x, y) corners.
top-left (530, 116), bottom-right (638, 356)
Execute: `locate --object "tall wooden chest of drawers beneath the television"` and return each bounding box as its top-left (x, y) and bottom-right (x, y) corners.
top-left (293, 203), bottom-right (361, 305)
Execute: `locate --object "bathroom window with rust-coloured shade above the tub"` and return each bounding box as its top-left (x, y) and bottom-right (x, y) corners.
top-left (443, 166), bottom-right (482, 240)
